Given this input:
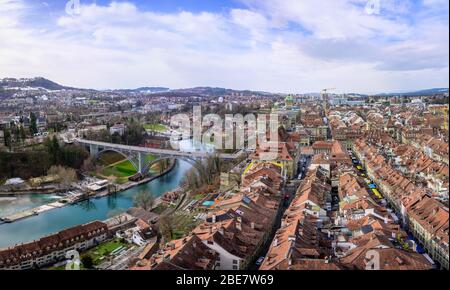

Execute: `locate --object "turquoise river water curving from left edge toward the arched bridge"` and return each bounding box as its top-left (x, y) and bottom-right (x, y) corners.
top-left (0, 139), bottom-right (210, 248)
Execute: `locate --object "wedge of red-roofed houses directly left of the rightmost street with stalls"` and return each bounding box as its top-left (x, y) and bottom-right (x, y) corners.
top-left (333, 172), bottom-right (434, 270)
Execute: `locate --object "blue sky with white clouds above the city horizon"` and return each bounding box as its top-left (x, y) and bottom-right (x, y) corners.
top-left (0, 0), bottom-right (449, 93)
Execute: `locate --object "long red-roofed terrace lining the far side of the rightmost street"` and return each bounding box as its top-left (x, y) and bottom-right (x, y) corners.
top-left (354, 139), bottom-right (449, 269)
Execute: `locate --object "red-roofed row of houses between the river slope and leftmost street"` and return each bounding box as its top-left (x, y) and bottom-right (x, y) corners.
top-left (131, 162), bottom-right (283, 270)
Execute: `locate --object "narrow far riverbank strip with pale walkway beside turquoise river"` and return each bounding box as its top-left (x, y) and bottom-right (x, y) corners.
top-left (0, 159), bottom-right (177, 224)
